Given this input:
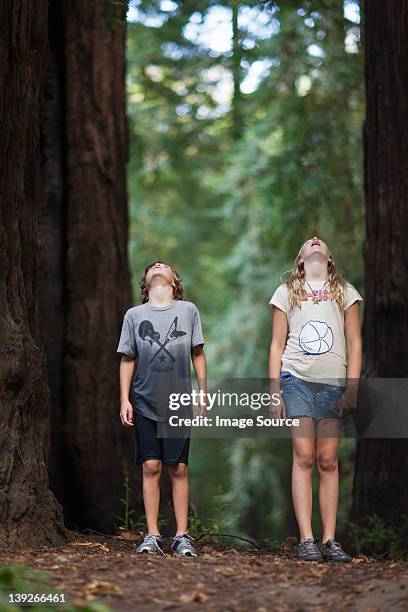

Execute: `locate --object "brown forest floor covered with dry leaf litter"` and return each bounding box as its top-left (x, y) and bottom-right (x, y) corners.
top-left (0, 532), bottom-right (408, 612)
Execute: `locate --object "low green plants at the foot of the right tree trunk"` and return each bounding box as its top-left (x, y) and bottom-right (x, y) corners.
top-left (350, 514), bottom-right (408, 560)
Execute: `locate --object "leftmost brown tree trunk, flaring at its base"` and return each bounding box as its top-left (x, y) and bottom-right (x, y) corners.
top-left (0, 0), bottom-right (64, 547)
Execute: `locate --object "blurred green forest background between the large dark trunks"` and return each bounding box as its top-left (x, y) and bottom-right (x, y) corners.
top-left (127, 0), bottom-right (365, 541)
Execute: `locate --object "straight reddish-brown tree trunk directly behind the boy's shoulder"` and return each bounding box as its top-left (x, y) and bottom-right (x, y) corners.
top-left (62, 0), bottom-right (136, 531)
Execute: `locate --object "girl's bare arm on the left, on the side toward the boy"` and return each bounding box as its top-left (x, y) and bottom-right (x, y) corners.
top-left (269, 306), bottom-right (288, 418)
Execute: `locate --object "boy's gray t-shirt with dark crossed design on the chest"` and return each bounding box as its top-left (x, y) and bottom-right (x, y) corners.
top-left (117, 300), bottom-right (204, 421)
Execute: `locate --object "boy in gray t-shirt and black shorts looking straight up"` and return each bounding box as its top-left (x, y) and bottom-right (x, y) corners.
top-left (117, 261), bottom-right (206, 557)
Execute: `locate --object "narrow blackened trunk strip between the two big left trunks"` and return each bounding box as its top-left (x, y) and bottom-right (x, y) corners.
top-left (37, 0), bottom-right (66, 502)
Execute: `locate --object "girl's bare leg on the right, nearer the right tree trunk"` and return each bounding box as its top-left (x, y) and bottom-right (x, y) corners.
top-left (316, 419), bottom-right (340, 542)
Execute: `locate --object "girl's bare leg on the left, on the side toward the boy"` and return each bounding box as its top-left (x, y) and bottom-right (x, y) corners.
top-left (292, 417), bottom-right (315, 542)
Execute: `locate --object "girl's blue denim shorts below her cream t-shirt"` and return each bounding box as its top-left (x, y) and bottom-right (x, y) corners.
top-left (280, 371), bottom-right (345, 421)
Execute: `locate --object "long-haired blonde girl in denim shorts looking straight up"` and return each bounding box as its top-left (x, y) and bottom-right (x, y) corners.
top-left (269, 236), bottom-right (362, 562)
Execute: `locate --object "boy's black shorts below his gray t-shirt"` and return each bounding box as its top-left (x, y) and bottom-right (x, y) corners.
top-left (134, 411), bottom-right (190, 465)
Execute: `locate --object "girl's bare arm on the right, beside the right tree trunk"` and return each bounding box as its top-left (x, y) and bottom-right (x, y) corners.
top-left (340, 302), bottom-right (362, 414)
